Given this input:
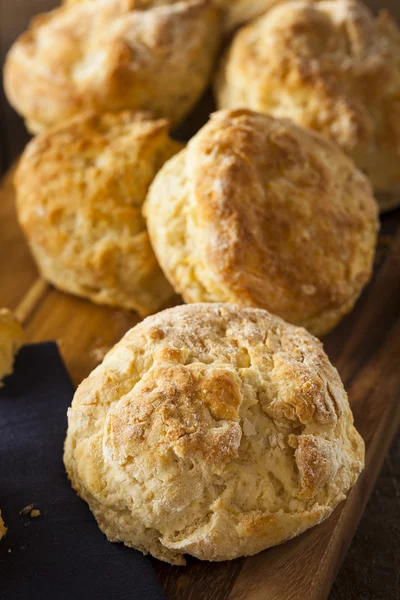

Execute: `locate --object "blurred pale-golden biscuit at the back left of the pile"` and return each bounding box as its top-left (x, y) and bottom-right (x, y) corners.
top-left (4, 0), bottom-right (219, 133)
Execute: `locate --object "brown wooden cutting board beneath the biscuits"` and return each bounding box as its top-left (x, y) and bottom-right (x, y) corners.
top-left (0, 164), bottom-right (400, 600)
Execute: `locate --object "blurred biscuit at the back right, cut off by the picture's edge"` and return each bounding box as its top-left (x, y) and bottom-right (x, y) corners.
top-left (216, 0), bottom-right (400, 209)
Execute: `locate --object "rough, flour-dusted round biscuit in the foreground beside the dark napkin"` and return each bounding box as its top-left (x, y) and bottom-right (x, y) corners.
top-left (64, 304), bottom-right (364, 565)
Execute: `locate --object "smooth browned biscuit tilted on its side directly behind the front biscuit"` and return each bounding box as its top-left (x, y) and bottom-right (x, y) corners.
top-left (145, 110), bottom-right (378, 335)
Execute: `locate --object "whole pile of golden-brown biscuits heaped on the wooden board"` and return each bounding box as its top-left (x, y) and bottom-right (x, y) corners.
top-left (4, 0), bottom-right (400, 565)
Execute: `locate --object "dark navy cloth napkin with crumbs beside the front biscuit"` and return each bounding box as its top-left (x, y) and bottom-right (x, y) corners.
top-left (0, 342), bottom-right (164, 600)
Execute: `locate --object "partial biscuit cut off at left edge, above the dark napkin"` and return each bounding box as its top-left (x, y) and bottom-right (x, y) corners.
top-left (0, 308), bottom-right (24, 386)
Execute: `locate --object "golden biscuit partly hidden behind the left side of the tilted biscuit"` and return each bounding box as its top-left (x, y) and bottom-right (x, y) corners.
top-left (15, 111), bottom-right (181, 315)
